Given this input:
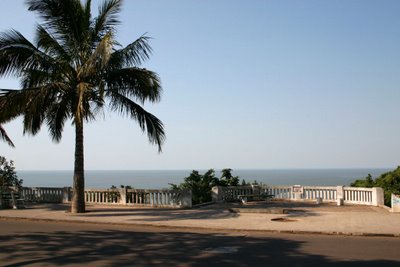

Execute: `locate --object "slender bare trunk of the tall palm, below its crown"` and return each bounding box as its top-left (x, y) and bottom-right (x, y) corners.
top-left (71, 121), bottom-right (85, 213)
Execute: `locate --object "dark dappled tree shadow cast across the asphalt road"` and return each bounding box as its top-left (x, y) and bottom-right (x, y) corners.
top-left (0, 224), bottom-right (400, 267)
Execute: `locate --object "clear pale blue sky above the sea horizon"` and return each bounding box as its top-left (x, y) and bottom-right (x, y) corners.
top-left (0, 0), bottom-right (400, 170)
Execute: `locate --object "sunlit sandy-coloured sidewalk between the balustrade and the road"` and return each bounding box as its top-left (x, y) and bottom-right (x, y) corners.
top-left (0, 201), bottom-right (400, 237)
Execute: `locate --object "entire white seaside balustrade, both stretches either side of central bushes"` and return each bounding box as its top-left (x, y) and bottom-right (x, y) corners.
top-left (20, 185), bottom-right (383, 207)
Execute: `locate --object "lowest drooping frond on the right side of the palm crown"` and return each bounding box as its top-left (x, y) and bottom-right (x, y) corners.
top-left (110, 93), bottom-right (165, 152)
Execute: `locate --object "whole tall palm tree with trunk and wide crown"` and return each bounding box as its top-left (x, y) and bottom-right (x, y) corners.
top-left (0, 0), bottom-right (165, 213)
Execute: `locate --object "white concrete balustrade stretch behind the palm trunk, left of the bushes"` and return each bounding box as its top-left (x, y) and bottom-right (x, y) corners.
top-left (19, 187), bottom-right (192, 207)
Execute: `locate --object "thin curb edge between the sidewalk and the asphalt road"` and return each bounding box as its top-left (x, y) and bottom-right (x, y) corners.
top-left (0, 216), bottom-right (400, 238)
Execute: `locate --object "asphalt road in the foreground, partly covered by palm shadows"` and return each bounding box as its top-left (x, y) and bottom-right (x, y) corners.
top-left (0, 220), bottom-right (400, 267)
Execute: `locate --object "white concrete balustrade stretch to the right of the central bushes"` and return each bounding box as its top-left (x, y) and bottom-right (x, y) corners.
top-left (212, 185), bottom-right (384, 206)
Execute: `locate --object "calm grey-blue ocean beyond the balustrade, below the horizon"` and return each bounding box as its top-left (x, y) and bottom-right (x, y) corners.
top-left (17, 168), bottom-right (390, 189)
